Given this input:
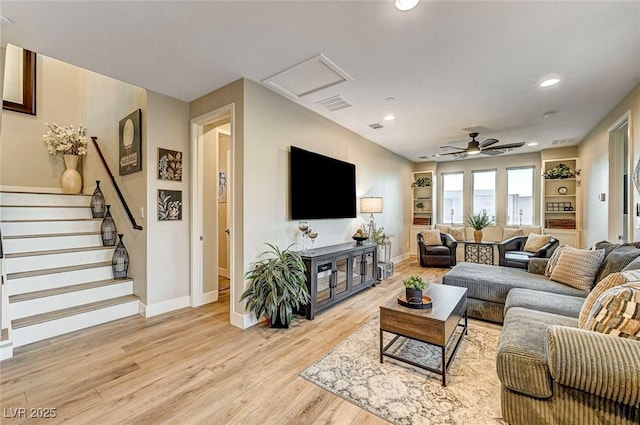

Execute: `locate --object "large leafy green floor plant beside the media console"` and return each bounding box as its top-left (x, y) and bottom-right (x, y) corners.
top-left (240, 244), bottom-right (311, 328)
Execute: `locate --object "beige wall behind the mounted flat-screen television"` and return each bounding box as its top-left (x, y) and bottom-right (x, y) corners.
top-left (244, 80), bottom-right (413, 268)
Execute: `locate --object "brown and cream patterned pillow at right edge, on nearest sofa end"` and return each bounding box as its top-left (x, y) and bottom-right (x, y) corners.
top-left (585, 282), bottom-right (640, 341)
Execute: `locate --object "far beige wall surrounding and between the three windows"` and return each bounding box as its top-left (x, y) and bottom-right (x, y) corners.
top-left (414, 152), bottom-right (541, 226)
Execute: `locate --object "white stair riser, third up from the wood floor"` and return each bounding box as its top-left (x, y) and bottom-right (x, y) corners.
top-left (6, 266), bottom-right (113, 296)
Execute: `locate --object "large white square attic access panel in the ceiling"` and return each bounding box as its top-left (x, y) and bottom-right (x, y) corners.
top-left (262, 55), bottom-right (353, 99)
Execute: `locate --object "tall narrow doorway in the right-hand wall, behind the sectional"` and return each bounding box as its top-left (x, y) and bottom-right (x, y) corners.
top-left (609, 112), bottom-right (633, 243)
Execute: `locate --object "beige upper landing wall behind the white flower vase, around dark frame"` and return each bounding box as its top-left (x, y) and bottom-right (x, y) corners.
top-left (0, 53), bottom-right (80, 189)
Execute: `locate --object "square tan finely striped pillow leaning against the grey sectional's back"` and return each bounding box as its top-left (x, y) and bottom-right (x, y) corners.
top-left (551, 246), bottom-right (604, 291)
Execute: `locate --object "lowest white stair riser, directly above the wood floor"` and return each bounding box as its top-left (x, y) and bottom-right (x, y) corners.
top-left (13, 301), bottom-right (140, 347)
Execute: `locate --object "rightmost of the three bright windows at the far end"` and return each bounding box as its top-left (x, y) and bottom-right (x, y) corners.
top-left (507, 167), bottom-right (534, 225)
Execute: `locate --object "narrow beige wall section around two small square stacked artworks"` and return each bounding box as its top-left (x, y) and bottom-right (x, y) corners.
top-left (146, 91), bottom-right (191, 306)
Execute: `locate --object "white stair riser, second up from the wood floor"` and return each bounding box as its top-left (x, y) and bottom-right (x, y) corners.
top-left (9, 281), bottom-right (133, 320)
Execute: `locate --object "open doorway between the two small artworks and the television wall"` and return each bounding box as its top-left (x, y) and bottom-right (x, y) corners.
top-left (191, 104), bottom-right (235, 323)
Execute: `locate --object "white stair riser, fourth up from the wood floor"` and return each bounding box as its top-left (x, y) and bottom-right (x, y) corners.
top-left (5, 247), bottom-right (114, 274)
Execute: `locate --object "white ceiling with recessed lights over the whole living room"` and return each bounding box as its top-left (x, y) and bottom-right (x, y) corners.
top-left (0, 0), bottom-right (640, 161)
